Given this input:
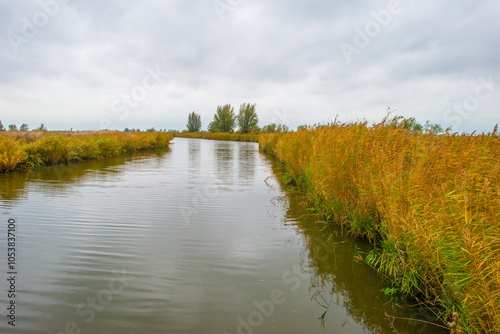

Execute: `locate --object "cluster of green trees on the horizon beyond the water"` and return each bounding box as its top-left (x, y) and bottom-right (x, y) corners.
top-left (186, 103), bottom-right (290, 134)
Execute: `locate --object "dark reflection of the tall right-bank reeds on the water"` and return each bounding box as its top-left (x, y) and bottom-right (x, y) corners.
top-left (272, 159), bottom-right (447, 334)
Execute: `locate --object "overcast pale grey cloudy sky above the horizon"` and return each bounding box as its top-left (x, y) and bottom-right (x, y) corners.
top-left (0, 0), bottom-right (500, 132)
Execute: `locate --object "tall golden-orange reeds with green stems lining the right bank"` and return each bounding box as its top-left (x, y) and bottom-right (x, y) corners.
top-left (259, 121), bottom-right (500, 333)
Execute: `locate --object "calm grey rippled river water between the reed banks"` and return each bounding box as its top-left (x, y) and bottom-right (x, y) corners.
top-left (0, 138), bottom-right (442, 334)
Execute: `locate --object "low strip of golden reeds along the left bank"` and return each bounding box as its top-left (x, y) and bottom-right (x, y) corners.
top-left (0, 131), bottom-right (173, 172)
